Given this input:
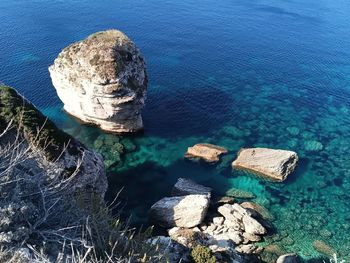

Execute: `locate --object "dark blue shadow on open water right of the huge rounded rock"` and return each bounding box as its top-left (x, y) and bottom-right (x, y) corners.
top-left (144, 86), bottom-right (233, 137)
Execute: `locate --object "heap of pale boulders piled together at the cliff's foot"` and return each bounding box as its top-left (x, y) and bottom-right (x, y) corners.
top-left (150, 178), bottom-right (268, 262)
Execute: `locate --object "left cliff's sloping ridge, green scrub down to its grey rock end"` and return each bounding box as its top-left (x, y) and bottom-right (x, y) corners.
top-left (0, 86), bottom-right (107, 197)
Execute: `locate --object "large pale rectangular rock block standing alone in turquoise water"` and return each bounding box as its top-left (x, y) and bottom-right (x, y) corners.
top-left (232, 148), bottom-right (299, 181)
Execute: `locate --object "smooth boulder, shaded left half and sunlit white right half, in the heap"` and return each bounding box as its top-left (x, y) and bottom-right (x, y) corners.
top-left (150, 195), bottom-right (209, 228)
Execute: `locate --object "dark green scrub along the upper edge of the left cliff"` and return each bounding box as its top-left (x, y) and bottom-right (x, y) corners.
top-left (0, 86), bottom-right (74, 160)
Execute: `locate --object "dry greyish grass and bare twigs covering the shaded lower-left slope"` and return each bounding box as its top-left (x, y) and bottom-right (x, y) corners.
top-left (0, 122), bottom-right (166, 263)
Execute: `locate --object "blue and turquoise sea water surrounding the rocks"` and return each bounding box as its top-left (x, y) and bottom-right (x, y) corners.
top-left (0, 0), bottom-right (350, 260)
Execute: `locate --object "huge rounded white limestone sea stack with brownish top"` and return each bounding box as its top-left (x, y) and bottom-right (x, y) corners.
top-left (49, 30), bottom-right (147, 133)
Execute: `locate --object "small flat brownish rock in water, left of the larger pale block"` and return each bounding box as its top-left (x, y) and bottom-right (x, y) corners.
top-left (185, 143), bottom-right (228, 163)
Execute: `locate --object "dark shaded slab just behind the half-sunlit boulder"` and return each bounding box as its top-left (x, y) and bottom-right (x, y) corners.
top-left (171, 178), bottom-right (212, 198)
